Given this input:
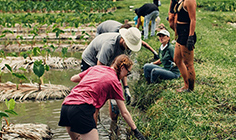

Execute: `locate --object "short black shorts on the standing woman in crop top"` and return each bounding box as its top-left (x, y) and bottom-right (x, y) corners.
top-left (176, 23), bottom-right (197, 45)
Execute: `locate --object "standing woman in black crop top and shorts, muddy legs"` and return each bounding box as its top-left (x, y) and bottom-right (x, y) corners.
top-left (174, 0), bottom-right (197, 92)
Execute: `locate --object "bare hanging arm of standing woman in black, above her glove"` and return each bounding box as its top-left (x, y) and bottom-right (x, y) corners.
top-left (184, 0), bottom-right (197, 36)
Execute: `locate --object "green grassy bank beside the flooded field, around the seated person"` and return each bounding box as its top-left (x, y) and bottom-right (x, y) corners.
top-left (106, 0), bottom-right (236, 140)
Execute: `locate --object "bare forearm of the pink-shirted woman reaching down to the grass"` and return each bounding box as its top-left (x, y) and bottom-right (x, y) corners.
top-left (116, 100), bottom-right (137, 130)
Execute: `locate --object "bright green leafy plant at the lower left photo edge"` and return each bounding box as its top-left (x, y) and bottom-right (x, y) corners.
top-left (0, 99), bottom-right (18, 126)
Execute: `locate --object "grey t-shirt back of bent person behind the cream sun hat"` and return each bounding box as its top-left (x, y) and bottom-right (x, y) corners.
top-left (97, 20), bottom-right (122, 35)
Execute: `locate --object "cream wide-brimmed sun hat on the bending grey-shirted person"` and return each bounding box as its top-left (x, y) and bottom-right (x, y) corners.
top-left (119, 27), bottom-right (142, 52)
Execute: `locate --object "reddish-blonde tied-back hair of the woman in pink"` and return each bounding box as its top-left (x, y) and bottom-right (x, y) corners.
top-left (111, 54), bottom-right (133, 75)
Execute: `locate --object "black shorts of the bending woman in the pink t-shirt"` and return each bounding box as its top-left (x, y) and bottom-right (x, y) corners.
top-left (58, 104), bottom-right (96, 134)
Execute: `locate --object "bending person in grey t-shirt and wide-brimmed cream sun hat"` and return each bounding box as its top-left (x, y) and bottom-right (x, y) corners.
top-left (81, 27), bottom-right (142, 127)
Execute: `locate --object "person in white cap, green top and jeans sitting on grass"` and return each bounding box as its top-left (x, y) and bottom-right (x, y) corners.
top-left (143, 30), bottom-right (180, 83)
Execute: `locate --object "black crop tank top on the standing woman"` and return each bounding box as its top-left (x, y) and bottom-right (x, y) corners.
top-left (175, 1), bottom-right (190, 23)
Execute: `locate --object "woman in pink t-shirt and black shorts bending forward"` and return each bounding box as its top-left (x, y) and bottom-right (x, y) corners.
top-left (58, 54), bottom-right (145, 140)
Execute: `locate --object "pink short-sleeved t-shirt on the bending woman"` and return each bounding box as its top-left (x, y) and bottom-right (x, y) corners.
top-left (62, 65), bottom-right (124, 108)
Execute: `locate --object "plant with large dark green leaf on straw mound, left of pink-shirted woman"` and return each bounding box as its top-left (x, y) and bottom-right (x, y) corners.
top-left (33, 60), bottom-right (49, 91)
